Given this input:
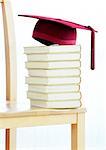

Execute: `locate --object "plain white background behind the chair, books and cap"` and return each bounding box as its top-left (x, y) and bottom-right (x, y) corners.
top-left (0, 0), bottom-right (106, 150)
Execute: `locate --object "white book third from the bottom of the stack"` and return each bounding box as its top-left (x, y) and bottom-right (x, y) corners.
top-left (28, 84), bottom-right (80, 93)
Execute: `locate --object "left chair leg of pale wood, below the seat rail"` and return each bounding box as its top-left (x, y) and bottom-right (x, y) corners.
top-left (5, 128), bottom-right (16, 150)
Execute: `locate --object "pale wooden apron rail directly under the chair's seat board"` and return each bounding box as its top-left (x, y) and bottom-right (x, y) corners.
top-left (0, 115), bottom-right (76, 128)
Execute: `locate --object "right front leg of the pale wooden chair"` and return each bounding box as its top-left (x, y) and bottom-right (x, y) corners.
top-left (71, 113), bottom-right (85, 150)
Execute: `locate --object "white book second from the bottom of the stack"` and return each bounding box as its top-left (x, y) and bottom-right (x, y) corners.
top-left (27, 91), bottom-right (81, 101)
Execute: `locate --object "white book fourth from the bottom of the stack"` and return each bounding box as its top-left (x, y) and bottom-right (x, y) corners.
top-left (26, 77), bottom-right (81, 85)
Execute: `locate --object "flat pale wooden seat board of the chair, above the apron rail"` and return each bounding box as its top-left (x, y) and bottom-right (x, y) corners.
top-left (0, 100), bottom-right (86, 118)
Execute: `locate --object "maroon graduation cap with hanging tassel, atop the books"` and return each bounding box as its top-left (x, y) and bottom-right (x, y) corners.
top-left (18, 15), bottom-right (97, 70)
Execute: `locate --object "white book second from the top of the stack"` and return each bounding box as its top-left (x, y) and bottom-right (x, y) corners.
top-left (27, 53), bottom-right (81, 61)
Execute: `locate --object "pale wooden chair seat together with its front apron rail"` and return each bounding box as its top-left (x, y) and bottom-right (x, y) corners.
top-left (0, 101), bottom-right (86, 128)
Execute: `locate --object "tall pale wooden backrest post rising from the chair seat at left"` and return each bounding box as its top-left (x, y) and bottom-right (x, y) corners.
top-left (0, 0), bottom-right (17, 101)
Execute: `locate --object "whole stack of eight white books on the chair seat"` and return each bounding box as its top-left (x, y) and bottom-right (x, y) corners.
top-left (24, 45), bottom-right (81, 108)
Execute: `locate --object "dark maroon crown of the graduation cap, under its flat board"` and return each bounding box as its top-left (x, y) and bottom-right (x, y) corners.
top-left (32, 19), bottom-right (76, 45)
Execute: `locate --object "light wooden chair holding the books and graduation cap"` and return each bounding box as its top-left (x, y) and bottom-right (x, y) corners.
top-left (0, 0), bottom-right (86, 150)
